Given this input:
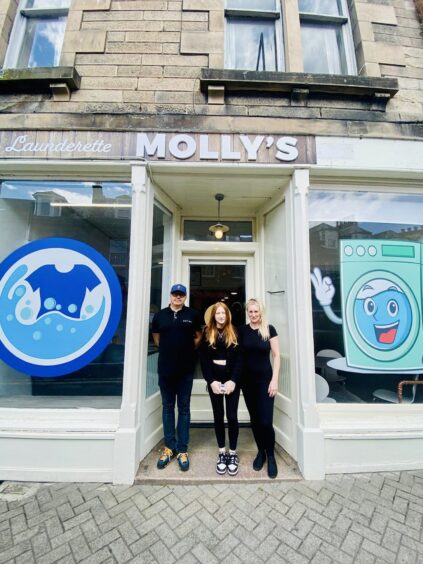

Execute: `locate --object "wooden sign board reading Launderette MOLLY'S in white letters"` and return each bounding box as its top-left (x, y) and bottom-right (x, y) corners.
top-left (0, 131), bottom-right (316, 164)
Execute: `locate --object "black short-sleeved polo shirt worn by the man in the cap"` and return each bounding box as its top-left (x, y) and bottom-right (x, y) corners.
top-left (151, 306), bottom-right (201, 376)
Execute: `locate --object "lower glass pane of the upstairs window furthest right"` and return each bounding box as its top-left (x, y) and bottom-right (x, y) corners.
top-left (301, 23), bottom-right (347, 74)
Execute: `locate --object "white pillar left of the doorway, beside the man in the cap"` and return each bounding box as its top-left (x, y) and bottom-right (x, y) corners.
top-left (113, 163), bottom-right (154, 484)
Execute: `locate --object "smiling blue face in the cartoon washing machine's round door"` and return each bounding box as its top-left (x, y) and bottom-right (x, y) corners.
top-left (354, 278), bottom-right (413, 351)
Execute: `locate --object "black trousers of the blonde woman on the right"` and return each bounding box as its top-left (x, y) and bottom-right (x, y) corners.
top-left (242, 380), bottom-right (275, 456)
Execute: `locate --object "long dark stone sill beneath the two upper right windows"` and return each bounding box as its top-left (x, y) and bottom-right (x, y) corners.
top-left (200, 69), bottom-right (399, 111)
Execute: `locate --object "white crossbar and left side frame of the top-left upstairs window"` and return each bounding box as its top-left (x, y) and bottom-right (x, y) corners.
top-left (3, 0), bottom-right (70, 68)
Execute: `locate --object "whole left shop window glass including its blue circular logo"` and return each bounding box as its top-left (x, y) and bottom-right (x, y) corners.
top-left (0, 180), bottom-right (131, 408)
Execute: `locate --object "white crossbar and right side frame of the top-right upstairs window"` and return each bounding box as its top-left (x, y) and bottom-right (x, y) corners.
top-left (298, 0), bottom-right (357, 75)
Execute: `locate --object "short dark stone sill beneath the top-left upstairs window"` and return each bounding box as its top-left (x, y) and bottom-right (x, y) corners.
top-left (0, 67), bottom-right (81, 100)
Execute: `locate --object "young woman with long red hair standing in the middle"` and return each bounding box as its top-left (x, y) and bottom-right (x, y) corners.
top-left (200, 302), bottom-right (241, 476)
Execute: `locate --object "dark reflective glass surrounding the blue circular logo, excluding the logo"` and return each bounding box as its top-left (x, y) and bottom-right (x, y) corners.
top-left (0, 180), bottom-right (131, 408)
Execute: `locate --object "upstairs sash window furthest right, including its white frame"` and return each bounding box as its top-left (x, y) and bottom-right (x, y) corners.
top-left (298, 0), bottom-right (356, 74)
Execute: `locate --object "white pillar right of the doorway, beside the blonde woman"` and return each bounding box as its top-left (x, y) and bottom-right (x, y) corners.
top-left (286, 169), bottom-right (325, 480)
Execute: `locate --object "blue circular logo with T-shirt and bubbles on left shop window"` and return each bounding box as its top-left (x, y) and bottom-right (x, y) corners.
top-left (0, 238), bottom-right (122, 377)
